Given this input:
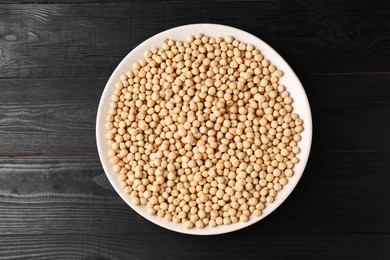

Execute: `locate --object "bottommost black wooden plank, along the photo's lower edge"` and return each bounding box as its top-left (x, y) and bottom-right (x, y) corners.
top-left (0, 233), bottom-right (390, 260)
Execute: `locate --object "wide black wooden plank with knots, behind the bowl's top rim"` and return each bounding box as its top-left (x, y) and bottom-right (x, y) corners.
top-left (0, 0), bottom-right (390, 77)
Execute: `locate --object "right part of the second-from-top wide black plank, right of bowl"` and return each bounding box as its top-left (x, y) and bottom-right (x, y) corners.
top-left (301, 75), bottom-right (390, 151)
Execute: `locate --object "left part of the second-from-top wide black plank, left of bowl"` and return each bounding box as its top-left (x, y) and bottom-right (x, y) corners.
top-left (0, 79), bottom-right (105, 154)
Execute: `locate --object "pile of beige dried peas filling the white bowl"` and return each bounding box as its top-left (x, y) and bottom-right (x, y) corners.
top-left (106, 34), bottom-right (303, 228)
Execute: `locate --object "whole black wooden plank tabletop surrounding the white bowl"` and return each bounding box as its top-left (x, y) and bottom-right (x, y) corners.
top-left (0, 0), bottom-right (390, 259)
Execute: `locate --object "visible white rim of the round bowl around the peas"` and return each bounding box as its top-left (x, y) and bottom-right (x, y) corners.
top-left (96, 24), bottom-right (312, 235)
